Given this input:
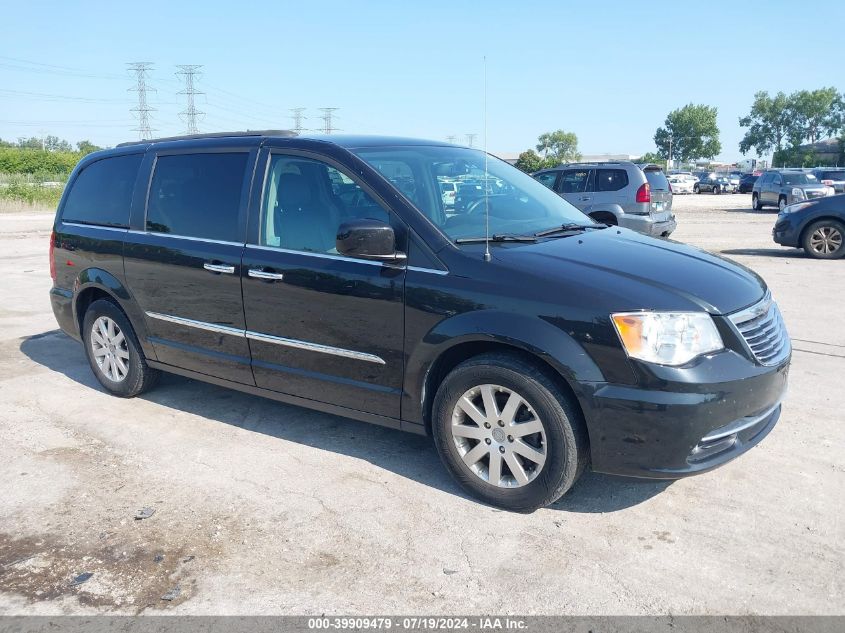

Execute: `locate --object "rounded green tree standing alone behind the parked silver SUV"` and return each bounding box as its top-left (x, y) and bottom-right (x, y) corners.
top-left (654, 103), bottom-right (722, 162)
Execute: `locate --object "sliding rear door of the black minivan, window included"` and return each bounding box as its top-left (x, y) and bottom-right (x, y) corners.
top-left (124, 148), bottom-right (257, 384)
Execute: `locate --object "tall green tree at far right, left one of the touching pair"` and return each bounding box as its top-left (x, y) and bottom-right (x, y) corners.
top-left (739, 90), bottom-right (796, 156)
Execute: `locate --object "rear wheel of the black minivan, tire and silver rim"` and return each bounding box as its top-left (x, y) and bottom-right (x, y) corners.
top-left (82, 299), bottom-right (160, 398)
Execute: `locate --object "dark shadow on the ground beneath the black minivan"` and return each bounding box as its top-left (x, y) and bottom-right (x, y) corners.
top-left (20, 330), bottom-right (671, 513)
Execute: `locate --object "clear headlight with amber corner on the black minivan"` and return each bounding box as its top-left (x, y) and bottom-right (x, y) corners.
top-left (610, 312), bottom-right (724, 366)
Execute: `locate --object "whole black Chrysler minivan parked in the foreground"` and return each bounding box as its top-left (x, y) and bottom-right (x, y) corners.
top-left (50, 132), bottom-right (791, 511)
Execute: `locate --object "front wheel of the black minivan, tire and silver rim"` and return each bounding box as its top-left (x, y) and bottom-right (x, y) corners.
top-left (431, 354), bottom-right (588, 512)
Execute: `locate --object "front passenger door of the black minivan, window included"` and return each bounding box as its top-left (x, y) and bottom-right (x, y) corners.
top-left (242, 153), bottom-right (407, 418)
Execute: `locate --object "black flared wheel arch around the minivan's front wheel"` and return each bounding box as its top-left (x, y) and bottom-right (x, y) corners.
top-left (402, 310), bottom-right (605, 424)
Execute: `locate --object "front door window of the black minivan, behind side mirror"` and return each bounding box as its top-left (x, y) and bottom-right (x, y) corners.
top-left (260, 154), bottom-right (390, 253)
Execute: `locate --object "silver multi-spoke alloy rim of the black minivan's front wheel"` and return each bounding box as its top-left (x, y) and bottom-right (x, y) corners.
top-left (450, 384), bottom-right (547, 488)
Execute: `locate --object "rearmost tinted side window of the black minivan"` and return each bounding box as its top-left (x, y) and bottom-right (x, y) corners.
top-left (62, 154), bottom-right (143, 227)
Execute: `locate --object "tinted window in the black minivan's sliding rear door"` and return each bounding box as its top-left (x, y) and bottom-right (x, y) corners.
top-left (147, 152), bottom-right (248, 241)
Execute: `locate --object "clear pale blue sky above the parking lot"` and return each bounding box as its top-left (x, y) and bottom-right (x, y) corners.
top-left (0, 0), bottom-right (845, 160)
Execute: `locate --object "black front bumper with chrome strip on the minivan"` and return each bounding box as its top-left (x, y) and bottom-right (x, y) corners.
top-left (584, 351), bottom-right (789, 479)
